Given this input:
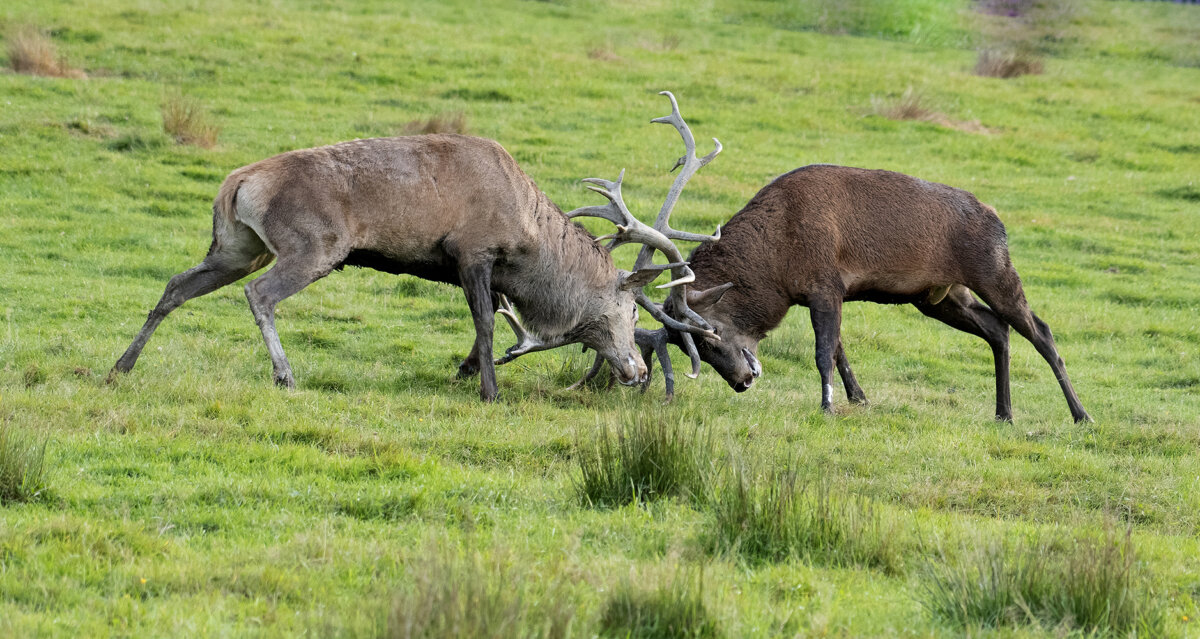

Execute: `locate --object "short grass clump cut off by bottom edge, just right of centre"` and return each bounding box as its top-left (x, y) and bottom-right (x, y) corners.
top-left (600, 573), bottom-right (721, 639)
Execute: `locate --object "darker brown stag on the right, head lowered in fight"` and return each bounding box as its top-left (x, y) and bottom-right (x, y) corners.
top-left (640, 165), bottom-right (1091, 422)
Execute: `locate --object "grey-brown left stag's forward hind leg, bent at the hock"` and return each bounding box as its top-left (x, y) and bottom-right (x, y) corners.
top-left (246, 252), bottom-right (344, 388)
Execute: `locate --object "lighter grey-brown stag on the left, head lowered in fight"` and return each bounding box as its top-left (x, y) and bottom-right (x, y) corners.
top-left (109, 101), bottom-right (707, 400)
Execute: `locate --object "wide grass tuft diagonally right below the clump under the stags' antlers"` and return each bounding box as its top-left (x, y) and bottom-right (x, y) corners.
top-left (709, 465), bottom-right (902, 573)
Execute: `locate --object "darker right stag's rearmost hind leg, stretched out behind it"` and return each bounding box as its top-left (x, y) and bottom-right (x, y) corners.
top-left (971, 259), bottom-right (1092, 422)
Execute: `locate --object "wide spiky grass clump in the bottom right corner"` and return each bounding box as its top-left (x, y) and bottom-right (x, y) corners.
top-left (919, 526), bottom-right (1165, 637)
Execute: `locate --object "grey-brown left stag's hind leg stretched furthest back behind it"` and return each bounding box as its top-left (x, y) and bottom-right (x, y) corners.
top-left (108, 222), bottom-right (272, 382)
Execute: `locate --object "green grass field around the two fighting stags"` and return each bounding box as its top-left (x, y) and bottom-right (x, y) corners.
top-left (0, 0), bottom-right (1200, 637)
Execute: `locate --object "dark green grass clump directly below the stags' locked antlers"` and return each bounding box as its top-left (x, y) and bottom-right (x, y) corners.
top-left (575, 411), bottom-right (716, 506)
